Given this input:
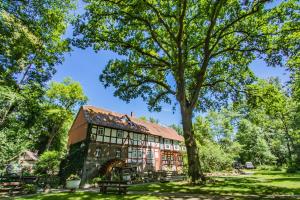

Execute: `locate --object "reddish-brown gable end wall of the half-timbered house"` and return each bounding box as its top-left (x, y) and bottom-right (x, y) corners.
top-left (68, 108), bottom-right (88, 146)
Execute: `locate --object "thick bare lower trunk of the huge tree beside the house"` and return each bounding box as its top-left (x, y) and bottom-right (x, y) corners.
top-left (181, 106), bottom-right (205, 183)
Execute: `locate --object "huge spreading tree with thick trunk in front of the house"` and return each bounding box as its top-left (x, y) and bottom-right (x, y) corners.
top-left (75, 0), bottom-right (299, 182)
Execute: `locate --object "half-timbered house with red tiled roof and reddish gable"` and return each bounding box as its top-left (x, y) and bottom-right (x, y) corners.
top-left (68, 106), bottom-right (185, 183)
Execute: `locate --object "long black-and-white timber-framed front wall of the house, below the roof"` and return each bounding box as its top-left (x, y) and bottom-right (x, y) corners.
top-left (82, 124), bottom-right (185, 180)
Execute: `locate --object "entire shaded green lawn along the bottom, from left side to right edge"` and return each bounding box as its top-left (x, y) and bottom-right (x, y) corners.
top-left (11, 171), bottom-right (300, 200)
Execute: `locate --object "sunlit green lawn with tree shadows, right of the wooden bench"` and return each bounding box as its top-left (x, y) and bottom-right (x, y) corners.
top-left (130, 171), bottom-right (300, 196)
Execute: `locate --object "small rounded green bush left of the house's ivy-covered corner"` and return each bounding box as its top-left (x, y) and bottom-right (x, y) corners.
top-left (35, 151), bottom-right (61, 176)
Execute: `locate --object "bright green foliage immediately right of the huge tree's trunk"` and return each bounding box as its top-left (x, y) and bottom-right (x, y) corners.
top-left (194, 109), bottom-right (241, 172)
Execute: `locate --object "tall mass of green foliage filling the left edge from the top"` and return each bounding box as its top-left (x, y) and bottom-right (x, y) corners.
top-left (0, 0), bottom-right (74, 169)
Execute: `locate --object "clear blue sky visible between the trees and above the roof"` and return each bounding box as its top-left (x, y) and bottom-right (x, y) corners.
top-left (53, 1), bottom-right (288, 125)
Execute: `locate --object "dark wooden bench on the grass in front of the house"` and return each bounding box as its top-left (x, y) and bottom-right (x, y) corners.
top-left (98, 181), bottom-right (128, 194)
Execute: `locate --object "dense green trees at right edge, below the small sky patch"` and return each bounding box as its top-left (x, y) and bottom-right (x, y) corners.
top-left (243, 79), bottom-right (299, 164)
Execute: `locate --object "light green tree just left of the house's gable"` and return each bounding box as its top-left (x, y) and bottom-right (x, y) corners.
top-left (39, 78), bottom-right (88, 153)
